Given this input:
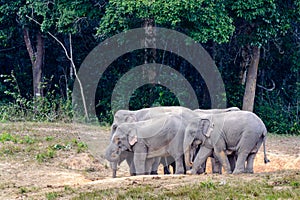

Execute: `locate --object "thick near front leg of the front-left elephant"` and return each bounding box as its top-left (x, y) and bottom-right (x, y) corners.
top-left (133, 143), bottom-right (147, 175)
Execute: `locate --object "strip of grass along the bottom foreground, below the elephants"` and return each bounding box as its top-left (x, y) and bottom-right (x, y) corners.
top-left (74, 175), bottom-right (300, 200)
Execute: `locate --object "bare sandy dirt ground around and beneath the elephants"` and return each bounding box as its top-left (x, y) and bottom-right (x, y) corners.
top-left (0, 123), bottom-right (300, 199)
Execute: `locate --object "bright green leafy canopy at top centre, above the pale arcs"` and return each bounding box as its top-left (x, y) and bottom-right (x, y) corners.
top-left (97, 0), bottom-right (234, 43)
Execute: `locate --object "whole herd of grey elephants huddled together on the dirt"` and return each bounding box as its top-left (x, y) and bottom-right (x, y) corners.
top-left (105, 106), bottom-right (269, 177)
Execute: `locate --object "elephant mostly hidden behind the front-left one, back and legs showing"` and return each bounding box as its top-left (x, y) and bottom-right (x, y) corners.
top-left (110, 106), bottom-right (198, 178)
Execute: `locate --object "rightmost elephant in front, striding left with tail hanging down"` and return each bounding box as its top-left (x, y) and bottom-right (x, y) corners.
top-left (183, 111), bottom-right (269, 174)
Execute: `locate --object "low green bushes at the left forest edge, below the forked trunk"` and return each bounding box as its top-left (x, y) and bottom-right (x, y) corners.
top-left (0, 72), bottom-right (72, 122)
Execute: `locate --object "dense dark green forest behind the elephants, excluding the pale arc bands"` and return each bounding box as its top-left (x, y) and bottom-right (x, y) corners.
top-left (0, 0), bottom-right (300, 134)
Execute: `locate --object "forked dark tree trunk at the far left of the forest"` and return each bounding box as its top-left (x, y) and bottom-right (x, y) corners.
top-left (23, 28), bottom-right (44, 97)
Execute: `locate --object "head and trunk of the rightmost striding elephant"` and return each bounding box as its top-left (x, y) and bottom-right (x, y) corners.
top-left (183, 118), bottom-right (213, 166)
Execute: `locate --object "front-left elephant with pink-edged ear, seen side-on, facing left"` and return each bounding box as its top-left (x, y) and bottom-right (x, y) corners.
top-left (106, 114), bottom-right (188, 175)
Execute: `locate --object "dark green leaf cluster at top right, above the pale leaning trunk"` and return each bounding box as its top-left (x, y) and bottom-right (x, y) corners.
top-left (228, 0), bottom-right (291, 46)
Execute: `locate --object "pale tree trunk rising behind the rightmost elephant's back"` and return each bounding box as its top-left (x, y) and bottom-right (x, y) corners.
top-left (243, 46), bottom-right (260, 112)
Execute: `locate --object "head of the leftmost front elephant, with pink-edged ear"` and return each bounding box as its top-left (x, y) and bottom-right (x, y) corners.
top-left (105, 124), bottom-right (137, 162)
